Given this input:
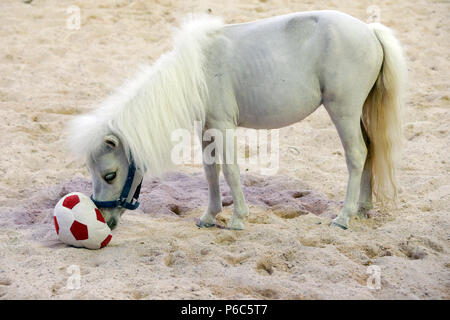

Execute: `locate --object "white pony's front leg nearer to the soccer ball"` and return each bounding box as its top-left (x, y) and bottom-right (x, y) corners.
top-left (197, 136), bottom-right (222, 228)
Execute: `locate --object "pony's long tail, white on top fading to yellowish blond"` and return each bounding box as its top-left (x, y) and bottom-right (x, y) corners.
top-left (363, 23), bottom-right (406, 205)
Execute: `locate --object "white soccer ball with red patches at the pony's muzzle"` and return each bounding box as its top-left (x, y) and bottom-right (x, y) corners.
top-left (53, 192), bottom-right (112, 249)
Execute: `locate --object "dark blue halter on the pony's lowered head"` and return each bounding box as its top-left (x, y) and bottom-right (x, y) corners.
top-left (91, 157), bottom-right (142, 210)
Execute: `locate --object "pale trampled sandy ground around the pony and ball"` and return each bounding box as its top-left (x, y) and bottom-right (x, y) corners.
top-left (0, 0), bottom-right (450, 299)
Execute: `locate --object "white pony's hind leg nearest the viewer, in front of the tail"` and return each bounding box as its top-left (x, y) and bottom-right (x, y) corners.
top-left (324, 101), bottom-right (367, 229)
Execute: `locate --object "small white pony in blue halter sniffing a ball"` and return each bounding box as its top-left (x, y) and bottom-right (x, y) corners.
top-left (71, 11), bottom-right (405, 229)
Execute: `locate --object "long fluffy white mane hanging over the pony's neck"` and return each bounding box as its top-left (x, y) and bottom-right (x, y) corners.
top-left (69, 16), bottom-right (223, 175)
